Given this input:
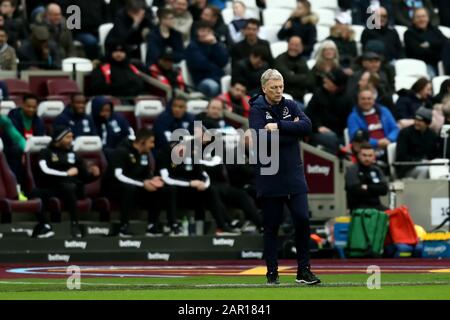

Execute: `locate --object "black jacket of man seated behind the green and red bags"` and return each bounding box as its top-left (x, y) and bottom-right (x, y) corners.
top-left (345, 163), bottom-right (388, 210)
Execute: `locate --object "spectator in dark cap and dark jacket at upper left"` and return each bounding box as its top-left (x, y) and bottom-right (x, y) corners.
top-left (17, 26), bottom-right (61, 70)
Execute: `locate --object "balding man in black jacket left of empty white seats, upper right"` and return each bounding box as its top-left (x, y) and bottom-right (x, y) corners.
top-left (361, 7), bottom-right (404, 61)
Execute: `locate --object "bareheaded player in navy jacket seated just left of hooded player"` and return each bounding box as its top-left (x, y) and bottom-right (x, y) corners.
top-left (53, 93), bottom-right (97, 138)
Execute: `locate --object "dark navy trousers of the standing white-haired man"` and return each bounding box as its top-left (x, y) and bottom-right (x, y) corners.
top-left (261, 194), bottom-right (310, 272)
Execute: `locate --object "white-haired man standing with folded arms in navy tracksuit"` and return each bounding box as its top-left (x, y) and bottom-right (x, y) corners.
top-left (249, 69), bottom-right (320, 284)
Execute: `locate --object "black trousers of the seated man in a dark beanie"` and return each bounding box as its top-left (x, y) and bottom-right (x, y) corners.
top-left (30, 182), bottom-right (85, 223)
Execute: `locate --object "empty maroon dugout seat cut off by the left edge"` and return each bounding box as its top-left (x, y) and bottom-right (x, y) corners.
top-left (0, 139), bottom-right (42, 223)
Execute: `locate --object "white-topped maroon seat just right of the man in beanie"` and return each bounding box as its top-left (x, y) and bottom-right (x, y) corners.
top-left (73, 137), bottom-right (111, 221)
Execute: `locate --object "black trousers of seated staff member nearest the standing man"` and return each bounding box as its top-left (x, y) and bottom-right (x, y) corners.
top-left (211, 183), bottom-right (263, 228)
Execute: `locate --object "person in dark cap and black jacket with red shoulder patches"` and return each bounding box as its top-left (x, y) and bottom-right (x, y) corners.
top-left (91, 43), bottom-right (145, 100)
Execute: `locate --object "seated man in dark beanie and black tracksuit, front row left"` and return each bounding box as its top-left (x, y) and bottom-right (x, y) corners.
top-left (31, 126), bottom-right (100, 238)
